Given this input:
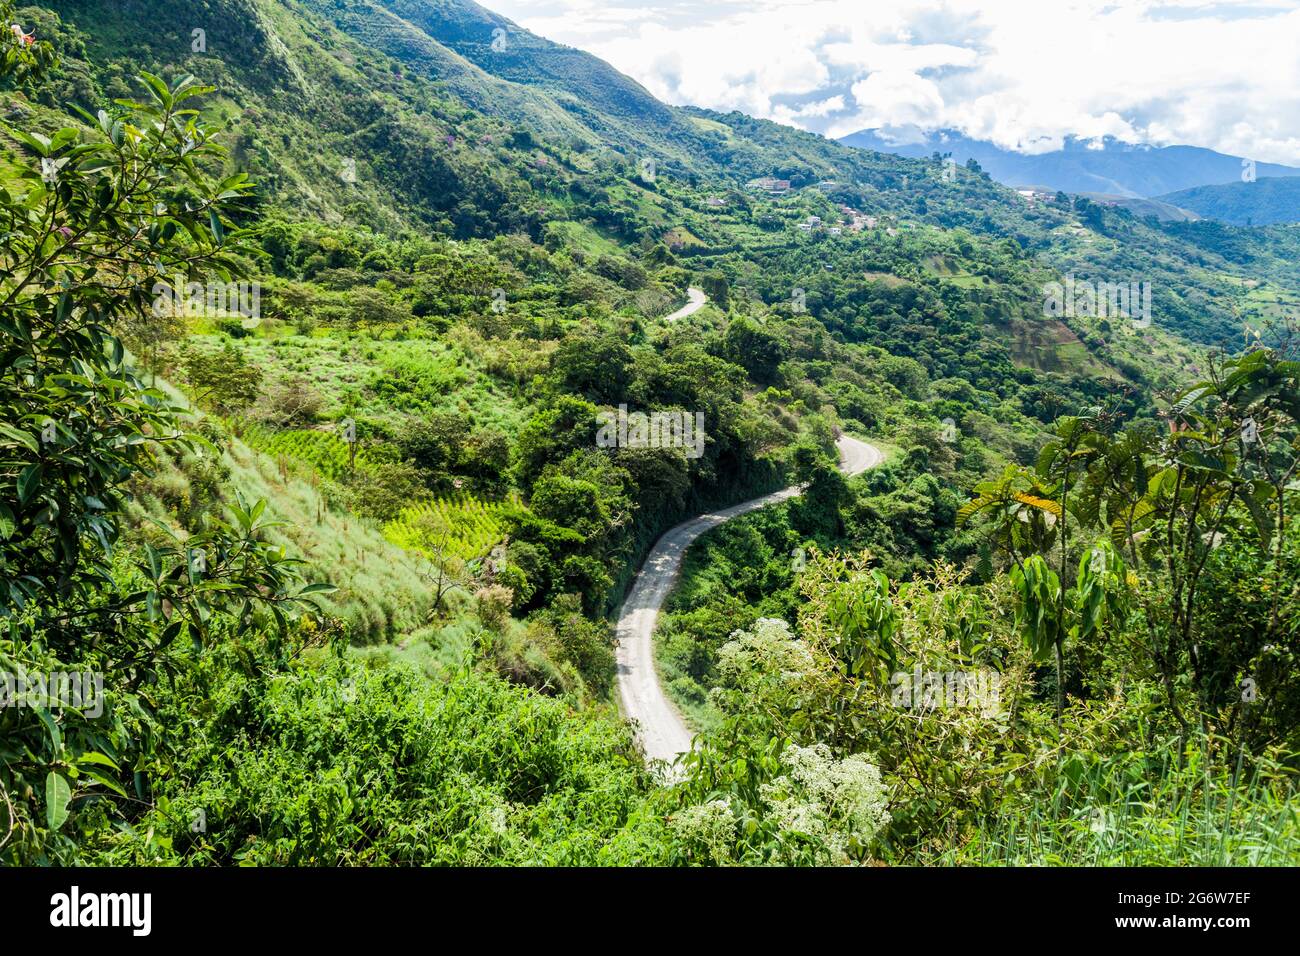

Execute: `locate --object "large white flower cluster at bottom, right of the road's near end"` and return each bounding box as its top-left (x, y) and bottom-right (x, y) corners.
top-left (762, 744), bottom-right (889, 862)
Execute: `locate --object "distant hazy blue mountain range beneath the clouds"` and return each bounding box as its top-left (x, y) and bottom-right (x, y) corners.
top-left (840, 127), bottom-right (1300, 202)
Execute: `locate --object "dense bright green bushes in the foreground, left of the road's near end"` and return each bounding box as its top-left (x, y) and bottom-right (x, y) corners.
top-left (91, 653), bottom-right (662, 866)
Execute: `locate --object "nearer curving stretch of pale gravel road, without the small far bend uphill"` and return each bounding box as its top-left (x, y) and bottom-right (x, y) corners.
top-left (616, 436), bottom-right (884, 763)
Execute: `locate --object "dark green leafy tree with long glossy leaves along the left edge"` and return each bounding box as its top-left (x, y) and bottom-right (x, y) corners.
top-left (0, 44), bottom-right (314, 862)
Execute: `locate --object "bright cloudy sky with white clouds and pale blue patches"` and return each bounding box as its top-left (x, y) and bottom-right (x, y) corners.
top-left (480, 0), bottom-right (1300, 164)
